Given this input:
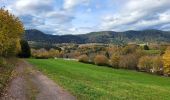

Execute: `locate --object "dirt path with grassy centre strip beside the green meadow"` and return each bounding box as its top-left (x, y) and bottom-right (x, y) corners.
top-left (0, 60), bottom-right (76, 100)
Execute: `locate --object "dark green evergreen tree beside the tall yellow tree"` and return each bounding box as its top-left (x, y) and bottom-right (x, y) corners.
top-left (18, 40), bottom-right (31, 58)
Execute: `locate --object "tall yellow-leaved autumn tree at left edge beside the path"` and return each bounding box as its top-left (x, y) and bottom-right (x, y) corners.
top-left (0, 8), bottom-right (24, 57)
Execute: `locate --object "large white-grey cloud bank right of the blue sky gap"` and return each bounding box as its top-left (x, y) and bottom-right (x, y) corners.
top-left (100, 0), bottom-right (170, 31)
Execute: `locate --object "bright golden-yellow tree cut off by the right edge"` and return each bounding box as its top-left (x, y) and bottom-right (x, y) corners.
top-left (163, 47), bottom-right (170, 76)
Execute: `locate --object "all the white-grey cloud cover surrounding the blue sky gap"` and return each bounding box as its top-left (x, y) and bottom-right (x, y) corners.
top-left (3, 0), bottom-right (170, 34)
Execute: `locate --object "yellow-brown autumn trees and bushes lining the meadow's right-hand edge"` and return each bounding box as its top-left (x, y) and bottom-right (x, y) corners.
top-left (76, 45), bottom-right (170, 76)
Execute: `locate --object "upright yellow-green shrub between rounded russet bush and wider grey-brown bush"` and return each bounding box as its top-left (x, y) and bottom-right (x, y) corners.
top-left (110, 55), bottom-right (120, 68)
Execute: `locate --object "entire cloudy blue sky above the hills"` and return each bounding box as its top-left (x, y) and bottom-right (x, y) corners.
top-left (0, 0), bottom-right (170, 35)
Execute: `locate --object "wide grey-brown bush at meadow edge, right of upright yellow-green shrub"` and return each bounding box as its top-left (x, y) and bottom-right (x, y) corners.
top-left (119, 54), bottom-right (138, 69)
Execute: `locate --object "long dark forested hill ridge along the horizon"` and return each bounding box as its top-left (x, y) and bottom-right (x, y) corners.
top-left (24, 29), bottom-right (170, 44)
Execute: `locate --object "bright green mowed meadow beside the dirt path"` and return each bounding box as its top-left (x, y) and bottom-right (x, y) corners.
top-left (28, 59), bottom-right (170, 100)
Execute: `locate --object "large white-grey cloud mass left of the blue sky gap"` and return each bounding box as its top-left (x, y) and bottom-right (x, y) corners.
top-left (7, 0), bottom-right (74, 34)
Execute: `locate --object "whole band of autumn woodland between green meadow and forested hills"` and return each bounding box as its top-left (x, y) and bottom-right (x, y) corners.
top-left (31, 44), bottom-right (170, 76)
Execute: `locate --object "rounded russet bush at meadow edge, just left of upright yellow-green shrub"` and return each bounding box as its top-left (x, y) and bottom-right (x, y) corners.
top-left (94, 55), bottom-right (108, 66)
